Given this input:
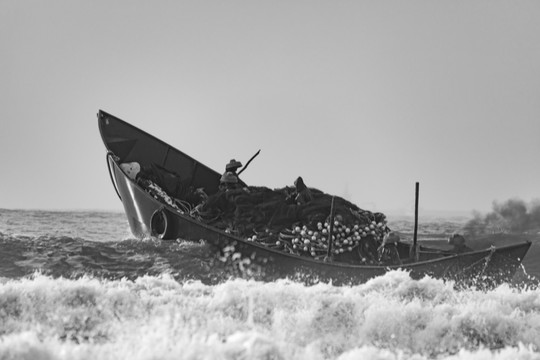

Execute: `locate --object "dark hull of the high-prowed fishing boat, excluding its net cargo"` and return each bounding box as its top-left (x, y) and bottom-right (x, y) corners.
top-left (98, 110), bottom-right (531, 285)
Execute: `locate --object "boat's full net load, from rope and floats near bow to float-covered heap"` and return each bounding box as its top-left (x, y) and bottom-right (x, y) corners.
top-left (133, 164), bottom-right (390, 264)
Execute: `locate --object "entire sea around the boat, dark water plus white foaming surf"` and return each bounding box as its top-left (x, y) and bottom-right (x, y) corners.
top-left (0, 210), bottom-right (540, 360)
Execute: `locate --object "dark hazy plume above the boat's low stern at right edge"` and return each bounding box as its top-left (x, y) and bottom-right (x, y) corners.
top-left (463, 199), bottom-right (540, 235)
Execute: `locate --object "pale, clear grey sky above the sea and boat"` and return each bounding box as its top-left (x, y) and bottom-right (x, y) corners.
top-left (0, 0), bottom-right (540, 217)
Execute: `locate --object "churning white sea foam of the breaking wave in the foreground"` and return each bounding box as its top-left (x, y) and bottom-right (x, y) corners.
top-left (0, 271), bottom-right (540, 360)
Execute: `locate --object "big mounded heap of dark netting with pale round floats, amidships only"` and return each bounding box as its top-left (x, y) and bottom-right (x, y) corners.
top-left (192, 186), bottom-right (389, 263)
